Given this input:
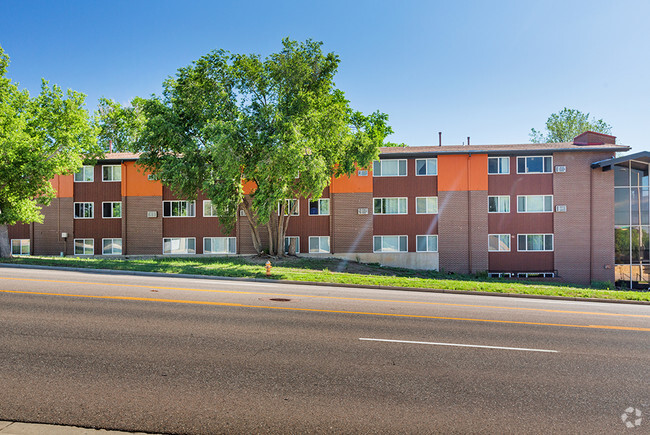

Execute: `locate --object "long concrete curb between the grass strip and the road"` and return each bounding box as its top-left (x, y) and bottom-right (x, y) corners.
top-left (0, 263), bottom-right (650, 305)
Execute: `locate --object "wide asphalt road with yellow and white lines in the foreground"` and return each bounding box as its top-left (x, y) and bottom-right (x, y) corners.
top-left (0, 267), bottom-right (650, 434)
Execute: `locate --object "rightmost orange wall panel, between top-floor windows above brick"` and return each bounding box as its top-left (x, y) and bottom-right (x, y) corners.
top-left (438, 154), bottom-right (487, 191)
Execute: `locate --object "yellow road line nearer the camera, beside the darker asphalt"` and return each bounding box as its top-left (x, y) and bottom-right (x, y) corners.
top-left (0, 290), bottom-right (650, 332)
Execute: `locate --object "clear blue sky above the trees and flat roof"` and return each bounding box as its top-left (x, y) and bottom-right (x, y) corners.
top-left (0, 0), bottom-right (650, 151)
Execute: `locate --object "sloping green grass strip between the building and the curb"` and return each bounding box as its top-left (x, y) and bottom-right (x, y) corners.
top-left (0, 257), bottom-right (650, 301)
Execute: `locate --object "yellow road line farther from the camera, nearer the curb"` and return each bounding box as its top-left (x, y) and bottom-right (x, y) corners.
top-left (0, 277), bottom-right (650, 318)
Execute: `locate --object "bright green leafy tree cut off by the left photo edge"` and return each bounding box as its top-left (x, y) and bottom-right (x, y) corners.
top-left (0, 47), bottom-right (99, 257)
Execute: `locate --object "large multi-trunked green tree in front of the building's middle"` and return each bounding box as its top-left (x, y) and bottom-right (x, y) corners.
top-left (123, 39), bottom-right (392, 256)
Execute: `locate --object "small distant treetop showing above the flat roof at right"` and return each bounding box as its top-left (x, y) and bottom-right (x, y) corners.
top-left (530, 107), bottom-right (612, 143)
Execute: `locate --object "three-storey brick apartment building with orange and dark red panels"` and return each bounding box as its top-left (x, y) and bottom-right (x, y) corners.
top-left (9, 132), bottom-right (632, 284)
